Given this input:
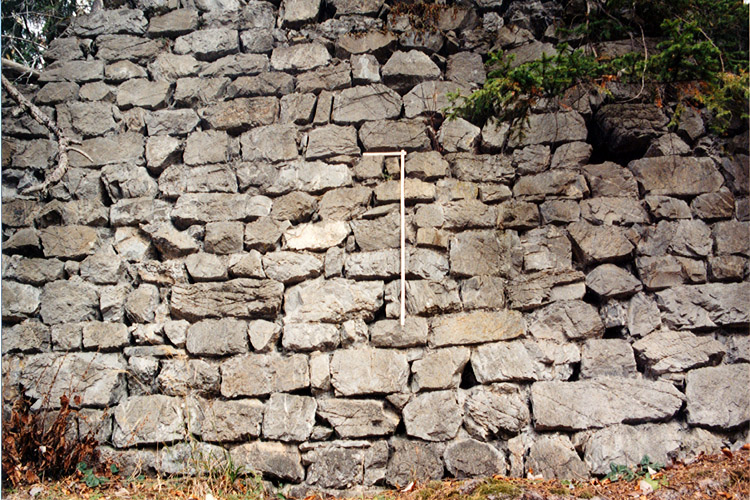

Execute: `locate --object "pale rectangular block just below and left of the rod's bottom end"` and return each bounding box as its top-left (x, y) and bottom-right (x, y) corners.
top-left (331, 347), bottom-right (409, 396)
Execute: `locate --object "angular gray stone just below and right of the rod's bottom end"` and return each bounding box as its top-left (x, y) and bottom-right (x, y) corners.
top-left (411, 347), bottom-right (469, 392)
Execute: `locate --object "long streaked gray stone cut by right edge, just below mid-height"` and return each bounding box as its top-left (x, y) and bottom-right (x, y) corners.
top-left (656, 283), bottom-right (750, 329)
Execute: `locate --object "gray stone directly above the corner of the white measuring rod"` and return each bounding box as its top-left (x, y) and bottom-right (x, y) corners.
top-left (359, 120), bottom-right (430, 151)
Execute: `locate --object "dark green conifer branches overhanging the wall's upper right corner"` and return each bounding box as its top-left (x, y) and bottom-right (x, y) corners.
top-left (451, 0), bottom-right (750, 133)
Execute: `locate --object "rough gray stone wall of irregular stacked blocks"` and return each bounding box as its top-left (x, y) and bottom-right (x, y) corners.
top-left (2, 0), bottom-right (750, 492)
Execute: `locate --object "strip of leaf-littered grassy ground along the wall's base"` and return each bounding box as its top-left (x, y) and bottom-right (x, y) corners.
top-left (3, 444), bottom-right (750, 500)
